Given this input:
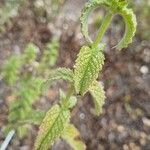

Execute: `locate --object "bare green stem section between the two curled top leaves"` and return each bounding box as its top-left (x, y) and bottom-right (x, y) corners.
top-left (93, 12), bottom-right (113, 47)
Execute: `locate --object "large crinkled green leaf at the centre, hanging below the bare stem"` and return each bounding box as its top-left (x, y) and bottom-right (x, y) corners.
top-left (74, 45), bottom-right (104, 95)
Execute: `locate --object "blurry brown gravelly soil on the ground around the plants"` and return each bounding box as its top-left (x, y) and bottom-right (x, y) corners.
top-left (0, 0), bottom-right (150, 150)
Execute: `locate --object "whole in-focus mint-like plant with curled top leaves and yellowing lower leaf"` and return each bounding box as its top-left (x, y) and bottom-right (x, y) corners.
top-left (35, 0), bottom-right (136, 150)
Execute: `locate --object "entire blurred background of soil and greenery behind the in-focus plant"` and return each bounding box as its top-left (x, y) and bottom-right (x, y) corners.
top-left (0, 0), bottom-right (150, 150)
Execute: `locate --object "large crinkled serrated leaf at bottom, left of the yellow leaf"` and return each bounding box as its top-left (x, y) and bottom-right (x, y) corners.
top-left (35, 105), bottom-right (70, 150)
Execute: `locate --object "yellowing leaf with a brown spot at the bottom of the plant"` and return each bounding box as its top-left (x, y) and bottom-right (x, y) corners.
top-left (62, 124), bottom-right (86, 150)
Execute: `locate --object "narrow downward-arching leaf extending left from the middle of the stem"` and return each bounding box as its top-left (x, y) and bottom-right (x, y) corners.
top-left (42, 68), bottom-right (73, 91)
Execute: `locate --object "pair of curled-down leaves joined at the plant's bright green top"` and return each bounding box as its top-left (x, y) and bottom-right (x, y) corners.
top-left (80, 0), bottom-right (137, 50)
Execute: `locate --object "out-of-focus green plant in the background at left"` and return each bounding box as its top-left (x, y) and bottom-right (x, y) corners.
top-left (2, 41), bottom-right (58, 137)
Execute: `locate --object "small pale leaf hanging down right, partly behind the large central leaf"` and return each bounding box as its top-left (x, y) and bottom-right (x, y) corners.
top-left (89, 81), bottom-right (105, 115)
